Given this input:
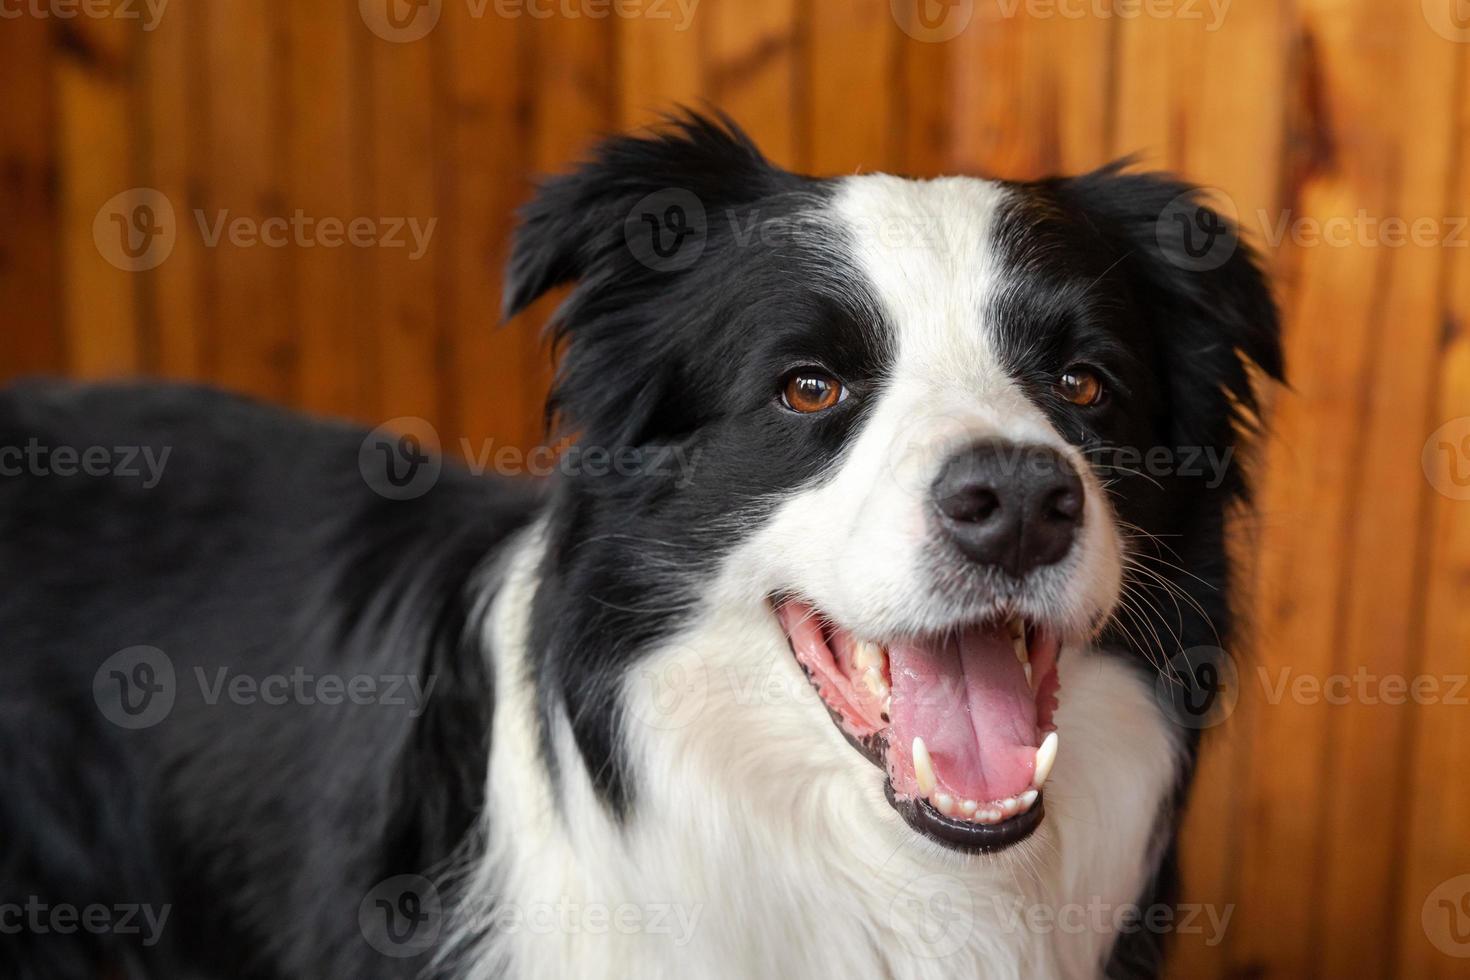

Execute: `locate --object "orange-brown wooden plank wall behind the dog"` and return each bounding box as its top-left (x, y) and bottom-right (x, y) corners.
top-left (0, 0), bottom-right (1470, 980)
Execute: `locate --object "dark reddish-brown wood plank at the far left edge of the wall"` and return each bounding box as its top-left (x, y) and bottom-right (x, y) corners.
top-left (0, 18), bottom-right (65, 382)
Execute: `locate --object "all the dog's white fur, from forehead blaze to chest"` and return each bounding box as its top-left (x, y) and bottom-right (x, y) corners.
top-left (446, 176), bottom-right (1180, 980)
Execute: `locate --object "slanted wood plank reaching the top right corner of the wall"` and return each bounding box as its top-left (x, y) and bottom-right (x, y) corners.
top-left (1316, 6), bottom-right (1470, 976)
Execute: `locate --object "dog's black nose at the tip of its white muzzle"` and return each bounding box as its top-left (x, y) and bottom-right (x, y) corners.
top-left (931, 441), bottom-right (1083, 577)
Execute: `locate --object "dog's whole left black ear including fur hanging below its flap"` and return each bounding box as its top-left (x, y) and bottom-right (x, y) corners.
top-left (504, 113), bottom-right (803, 444)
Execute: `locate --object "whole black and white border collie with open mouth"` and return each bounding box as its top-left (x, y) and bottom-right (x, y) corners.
top-left (0, 115), bottom-right (1282, 980)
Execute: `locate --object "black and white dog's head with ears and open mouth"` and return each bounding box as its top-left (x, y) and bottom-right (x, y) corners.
top-left (507, 110), bottom-right (1282, 849)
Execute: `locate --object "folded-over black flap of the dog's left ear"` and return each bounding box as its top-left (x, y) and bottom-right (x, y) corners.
top-left (504, 112), bottom-right (782, 317)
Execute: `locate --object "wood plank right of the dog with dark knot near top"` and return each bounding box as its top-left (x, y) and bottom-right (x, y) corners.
top-left (1230, 0), bottom-right (1392, 977)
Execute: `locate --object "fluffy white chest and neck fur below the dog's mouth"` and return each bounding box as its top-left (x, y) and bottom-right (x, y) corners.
top-left (446, 532), bottom-right (1179, 979)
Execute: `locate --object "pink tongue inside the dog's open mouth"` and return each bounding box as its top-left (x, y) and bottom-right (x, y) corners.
top-left (888, 626), bottom-right (1039, 804)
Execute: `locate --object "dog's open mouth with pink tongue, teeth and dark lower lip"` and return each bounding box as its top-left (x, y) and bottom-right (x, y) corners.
top-left (776, 599), bottom-right (1060, 851)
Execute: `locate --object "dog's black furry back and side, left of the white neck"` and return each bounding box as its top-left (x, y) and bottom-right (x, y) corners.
top-left (0, 382), bottom-right (535, 977)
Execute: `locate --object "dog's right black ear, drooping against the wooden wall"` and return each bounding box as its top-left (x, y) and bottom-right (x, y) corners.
top-left (1055, 162), bottom-right (1285, 470)
